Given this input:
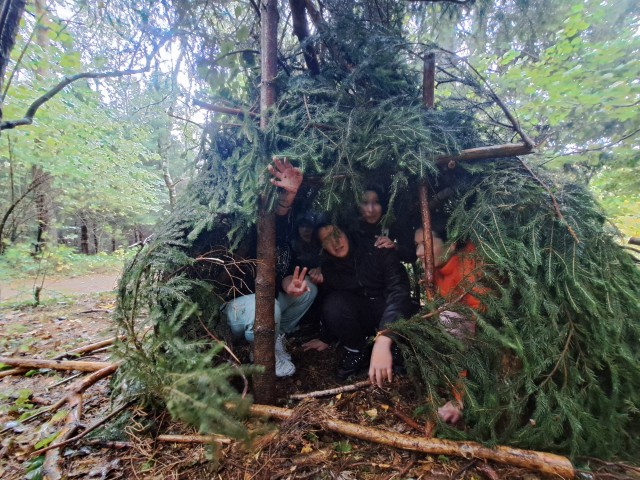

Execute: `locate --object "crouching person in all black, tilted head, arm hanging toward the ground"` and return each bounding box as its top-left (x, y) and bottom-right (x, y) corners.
top-left (303, 223), bottom-right (412, 386)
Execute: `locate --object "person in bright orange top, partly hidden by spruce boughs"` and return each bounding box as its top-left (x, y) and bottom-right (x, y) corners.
top-left (415, 224), bottom-right (486, 424)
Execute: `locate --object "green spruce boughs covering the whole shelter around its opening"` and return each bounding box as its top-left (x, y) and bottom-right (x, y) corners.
top-left (116, 4), bottom-right (640, 458)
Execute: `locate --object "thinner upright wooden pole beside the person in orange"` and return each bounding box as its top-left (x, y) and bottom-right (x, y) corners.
top-left (418, 53), bottom-right (436, 299)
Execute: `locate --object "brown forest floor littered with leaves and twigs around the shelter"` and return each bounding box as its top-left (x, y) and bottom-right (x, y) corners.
top-left (0, 279), bottom-right (640, 480)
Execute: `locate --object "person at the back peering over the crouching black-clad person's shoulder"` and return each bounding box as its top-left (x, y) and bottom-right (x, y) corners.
top-left (358, 185), bottom-right (416, 263)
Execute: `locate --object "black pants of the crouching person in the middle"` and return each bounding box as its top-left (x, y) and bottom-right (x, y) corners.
top-left (322, 291), bottom-right (386, 350)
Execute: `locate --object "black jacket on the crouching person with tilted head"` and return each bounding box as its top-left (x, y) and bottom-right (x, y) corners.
top-left (322, 233), bottom-right (411, 330)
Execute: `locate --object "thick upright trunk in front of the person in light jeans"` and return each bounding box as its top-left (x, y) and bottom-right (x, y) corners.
top-left (253, 0), bottom-right (278, 403)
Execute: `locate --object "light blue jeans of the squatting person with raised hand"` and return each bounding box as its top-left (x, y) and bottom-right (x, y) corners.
top-left (222, 277), bottom-right (318, 342)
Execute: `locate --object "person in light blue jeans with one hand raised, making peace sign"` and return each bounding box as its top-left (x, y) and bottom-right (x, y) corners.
top-left (222, 158), bottom-right (318, 377)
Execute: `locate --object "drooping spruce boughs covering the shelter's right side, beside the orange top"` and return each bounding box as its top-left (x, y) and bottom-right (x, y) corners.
top-left (394, 161), bottom-right (640, 458)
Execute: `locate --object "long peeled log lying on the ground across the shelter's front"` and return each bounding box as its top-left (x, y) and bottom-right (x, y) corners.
top-left (251, 404), bottom-right (575, 478)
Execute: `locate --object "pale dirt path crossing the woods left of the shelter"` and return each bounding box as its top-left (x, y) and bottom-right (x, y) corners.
top-left (0, 273), bottom-right (119, 302)
